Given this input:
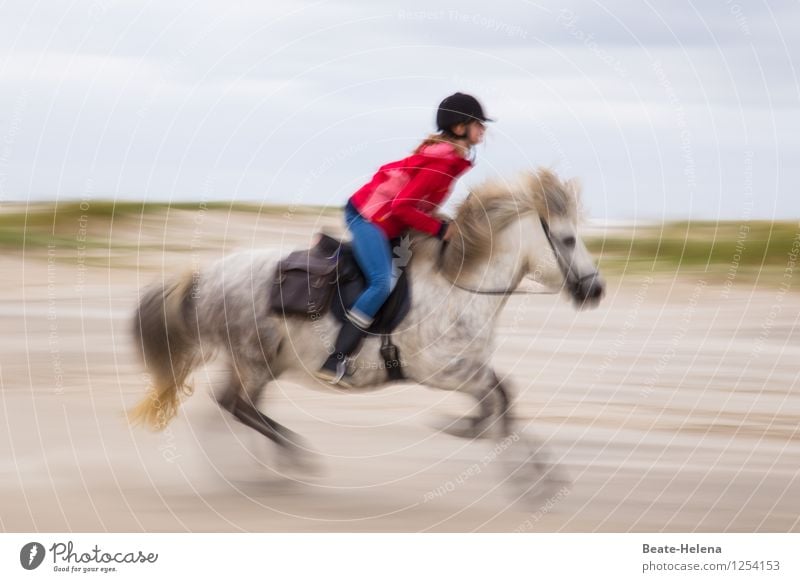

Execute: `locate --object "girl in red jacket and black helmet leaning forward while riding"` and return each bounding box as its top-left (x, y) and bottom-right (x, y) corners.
top-left (316, 93), bottom-right (493, 388)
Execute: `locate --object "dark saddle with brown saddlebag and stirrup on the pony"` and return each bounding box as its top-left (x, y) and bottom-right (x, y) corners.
top-left (269, 233), bottom-right (411, 380)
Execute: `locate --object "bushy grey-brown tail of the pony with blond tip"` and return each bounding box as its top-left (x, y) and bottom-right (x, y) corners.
top-left (128, 272), bottom-right (199, 430)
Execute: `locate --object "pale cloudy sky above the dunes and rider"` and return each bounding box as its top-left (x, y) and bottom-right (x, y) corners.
top-left (0, 0), bottom-right (800, 220)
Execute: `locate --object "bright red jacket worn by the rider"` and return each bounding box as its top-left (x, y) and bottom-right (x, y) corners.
top-left (350, 143), bottom-right (472, 238)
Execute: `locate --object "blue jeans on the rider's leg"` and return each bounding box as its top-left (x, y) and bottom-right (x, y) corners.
top-left (344, 202), bottom-right (392, 327)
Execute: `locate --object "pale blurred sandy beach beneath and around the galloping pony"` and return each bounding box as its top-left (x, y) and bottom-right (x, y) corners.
top-left (0, 212), bottom-right (800, 532)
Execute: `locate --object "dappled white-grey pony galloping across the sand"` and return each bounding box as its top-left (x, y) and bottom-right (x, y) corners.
top-left (131, 169), bottom-right (604, 470)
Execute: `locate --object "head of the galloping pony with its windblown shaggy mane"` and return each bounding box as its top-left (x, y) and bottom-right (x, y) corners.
top-left (441, 169), bottom-right (605, 308)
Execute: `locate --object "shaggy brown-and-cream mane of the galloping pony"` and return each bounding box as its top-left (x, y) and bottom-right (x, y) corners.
top-left (415, 168), bottom-right (580, 277)
